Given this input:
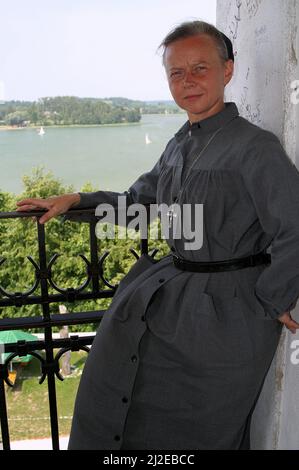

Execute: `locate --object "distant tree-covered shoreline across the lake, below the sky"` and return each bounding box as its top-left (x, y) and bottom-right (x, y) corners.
top-left (0, 96), bottom-right (179, 128)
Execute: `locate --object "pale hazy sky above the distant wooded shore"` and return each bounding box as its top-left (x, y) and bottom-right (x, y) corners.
top-left (0, 0), bottom-right (216, 101)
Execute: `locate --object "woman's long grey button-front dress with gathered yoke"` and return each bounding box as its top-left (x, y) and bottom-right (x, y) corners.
top-left (69, 103), bottom-right (299, 450)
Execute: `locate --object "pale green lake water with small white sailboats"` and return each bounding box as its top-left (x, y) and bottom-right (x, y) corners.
top-left (0, 113), bottom-right (187, 194)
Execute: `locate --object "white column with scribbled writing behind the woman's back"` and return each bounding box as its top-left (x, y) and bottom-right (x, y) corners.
top-left (217, 0), bottom-right (299, 449)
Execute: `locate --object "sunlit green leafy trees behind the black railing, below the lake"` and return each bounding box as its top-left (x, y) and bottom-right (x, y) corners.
top-left (0, 166), bottom-right (169, 331)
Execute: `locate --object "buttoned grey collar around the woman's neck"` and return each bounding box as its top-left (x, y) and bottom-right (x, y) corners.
top-left (174, 102), bottom-right (239, 140)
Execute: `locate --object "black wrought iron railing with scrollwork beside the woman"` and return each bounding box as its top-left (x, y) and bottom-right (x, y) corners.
top-left (0, 209), bottom-right (156, 450)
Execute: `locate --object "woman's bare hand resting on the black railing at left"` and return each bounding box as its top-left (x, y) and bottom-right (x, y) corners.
top-left (16, 193), bottom-right (80, 224)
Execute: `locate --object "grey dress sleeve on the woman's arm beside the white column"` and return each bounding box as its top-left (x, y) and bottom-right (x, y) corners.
top-left (242, 131), bottom-right (299, 319)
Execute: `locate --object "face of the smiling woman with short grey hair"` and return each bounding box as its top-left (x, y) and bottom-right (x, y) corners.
top-left (164, 34), bottom-right (234, 122)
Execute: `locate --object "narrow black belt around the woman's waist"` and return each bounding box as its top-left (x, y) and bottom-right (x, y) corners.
top-left (172, 252), bottom-right (271, 273)
